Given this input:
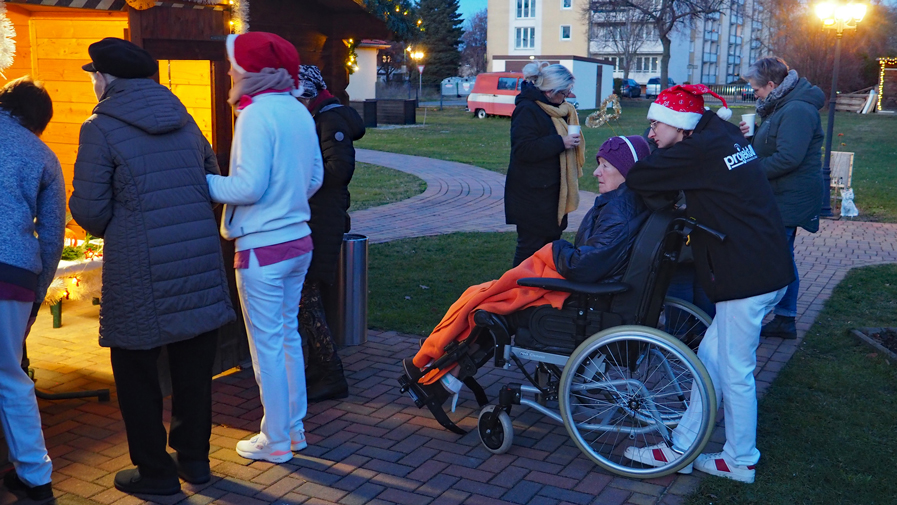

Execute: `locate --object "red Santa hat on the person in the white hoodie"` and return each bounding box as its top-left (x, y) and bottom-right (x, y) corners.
top-left (227, 32), bottom-right (299, 88)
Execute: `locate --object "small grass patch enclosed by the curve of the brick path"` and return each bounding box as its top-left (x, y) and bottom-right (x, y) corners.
top-left (349, 163), bottom-right (427, 212)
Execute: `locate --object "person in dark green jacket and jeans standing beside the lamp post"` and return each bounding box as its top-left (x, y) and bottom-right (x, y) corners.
top-left (741, 58), bottom-right (825, 339)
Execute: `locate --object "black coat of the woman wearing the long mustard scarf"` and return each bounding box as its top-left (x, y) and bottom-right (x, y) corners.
top-left (505, 86), bottom-right (567, 236)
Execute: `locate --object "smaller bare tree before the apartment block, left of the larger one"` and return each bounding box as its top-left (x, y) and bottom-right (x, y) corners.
top-left (591, 9), bottom-right (650, 79)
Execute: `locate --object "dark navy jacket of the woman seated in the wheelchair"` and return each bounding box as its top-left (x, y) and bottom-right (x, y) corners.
top-left (551, 184), bottom-right (650, 282)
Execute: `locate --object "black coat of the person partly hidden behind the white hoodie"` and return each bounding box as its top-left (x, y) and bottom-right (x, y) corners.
top-left (306, 98), bottom-right (364, 284)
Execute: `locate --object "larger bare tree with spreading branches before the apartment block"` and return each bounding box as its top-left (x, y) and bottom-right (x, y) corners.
top-left (589, 0), bottom-right (727, 91)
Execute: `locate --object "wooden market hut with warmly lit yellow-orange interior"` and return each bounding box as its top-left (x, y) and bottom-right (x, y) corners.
top-left (0, 0), bottom-right (389, 372)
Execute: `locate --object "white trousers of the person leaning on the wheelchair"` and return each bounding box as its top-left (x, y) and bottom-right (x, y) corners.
top-left (673, 288), bottom-right (786, 466)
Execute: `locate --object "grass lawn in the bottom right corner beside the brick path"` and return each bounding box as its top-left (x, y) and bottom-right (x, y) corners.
top-left (687, 265), bottom-right (897, 505)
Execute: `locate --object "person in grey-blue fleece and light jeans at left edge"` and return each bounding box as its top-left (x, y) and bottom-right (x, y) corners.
top-left (0, 77), bottom-right (65, 500)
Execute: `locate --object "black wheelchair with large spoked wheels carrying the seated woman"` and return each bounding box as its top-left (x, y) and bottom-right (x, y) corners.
top-left (399, 208), bottom-right (725, 478)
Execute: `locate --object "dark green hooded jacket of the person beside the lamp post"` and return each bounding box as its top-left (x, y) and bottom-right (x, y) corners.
top-left (752, 79), bottom-right (825, 232)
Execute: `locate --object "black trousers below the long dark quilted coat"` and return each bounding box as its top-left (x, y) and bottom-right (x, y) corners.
top-left (111, 330), bottom-right (218, 477)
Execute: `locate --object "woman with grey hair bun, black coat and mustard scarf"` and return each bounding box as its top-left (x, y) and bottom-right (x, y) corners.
top-left (505, 62), bottom-right (585, 266)
